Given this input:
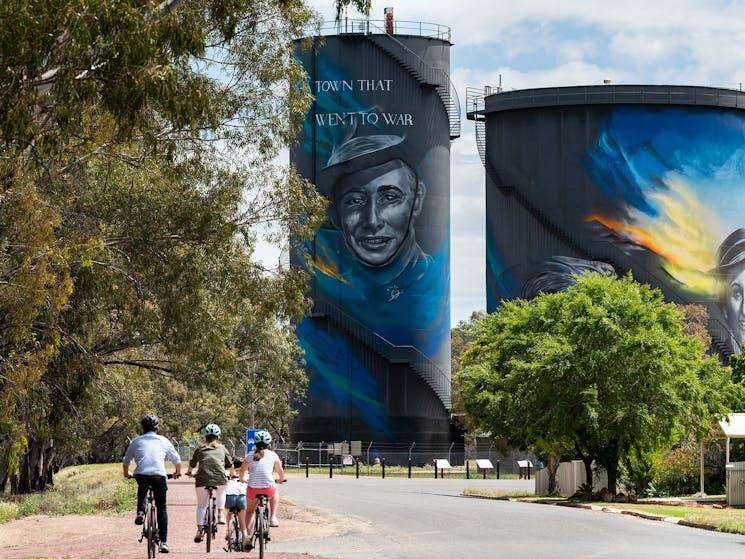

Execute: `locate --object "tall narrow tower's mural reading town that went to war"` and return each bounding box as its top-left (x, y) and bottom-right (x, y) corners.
top-left (291, 29), bottom-right (450, 440)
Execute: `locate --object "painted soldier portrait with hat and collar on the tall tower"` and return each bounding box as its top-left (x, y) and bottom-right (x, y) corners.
top-left (319, 134), bottom-right (432, 303)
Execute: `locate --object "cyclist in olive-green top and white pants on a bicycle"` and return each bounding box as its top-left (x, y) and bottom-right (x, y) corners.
top-left (186, 423), bottom-right (233, 543)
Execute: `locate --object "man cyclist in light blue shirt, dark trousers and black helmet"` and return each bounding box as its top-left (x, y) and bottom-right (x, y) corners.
top-left (122, 415), bottom-right (181, 553)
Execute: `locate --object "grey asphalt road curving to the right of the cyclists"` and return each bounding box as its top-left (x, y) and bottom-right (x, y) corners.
top-left (272, 476), bottom-right (745, 559)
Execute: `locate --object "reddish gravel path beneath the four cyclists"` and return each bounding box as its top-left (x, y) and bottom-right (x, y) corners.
top-left (0, 478), bottom-right (337, 559)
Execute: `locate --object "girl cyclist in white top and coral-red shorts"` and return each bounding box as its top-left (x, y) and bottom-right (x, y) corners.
top-left (240, 431), bottom-right (285, 551)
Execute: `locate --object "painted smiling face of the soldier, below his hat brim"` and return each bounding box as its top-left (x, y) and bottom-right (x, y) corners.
top-left (334, 159), bottom-right (423, 268)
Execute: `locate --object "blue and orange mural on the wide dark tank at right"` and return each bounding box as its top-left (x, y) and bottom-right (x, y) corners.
top-left (487, 92), bottom-right (745, 354)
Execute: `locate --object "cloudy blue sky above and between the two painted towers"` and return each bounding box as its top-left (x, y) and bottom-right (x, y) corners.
top-left (298, 0), bottom-right (745, 325)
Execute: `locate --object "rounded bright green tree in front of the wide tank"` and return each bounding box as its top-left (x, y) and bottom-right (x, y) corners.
top-left (459, 274), bottom-right (734, 492)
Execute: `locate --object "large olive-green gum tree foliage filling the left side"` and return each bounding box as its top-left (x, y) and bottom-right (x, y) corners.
top-left (0, 0), bottom-right (324, 492)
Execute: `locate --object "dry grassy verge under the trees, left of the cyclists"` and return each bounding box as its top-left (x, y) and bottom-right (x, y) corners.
top-left (0, 464), bottom-right (137, 524)
